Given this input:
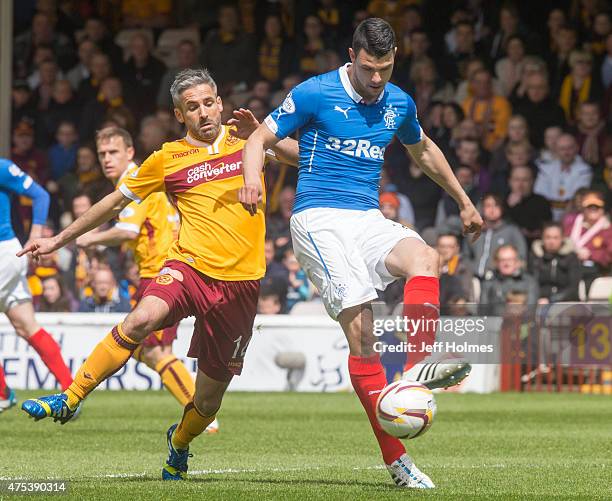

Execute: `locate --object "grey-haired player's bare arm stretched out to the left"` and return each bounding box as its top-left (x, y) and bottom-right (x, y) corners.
top-left (17, 190), bottom-right (131, 258)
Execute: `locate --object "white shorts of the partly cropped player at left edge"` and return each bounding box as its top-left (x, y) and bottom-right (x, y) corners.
top-left (0, 238), bottom-right (32, 313)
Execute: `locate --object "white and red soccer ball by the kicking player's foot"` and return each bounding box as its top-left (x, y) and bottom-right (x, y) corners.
top-left (376, 381), bottom-right (436, 438)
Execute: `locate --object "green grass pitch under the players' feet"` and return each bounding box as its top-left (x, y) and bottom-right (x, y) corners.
top-left (0, 391), bottom-right (612, 501)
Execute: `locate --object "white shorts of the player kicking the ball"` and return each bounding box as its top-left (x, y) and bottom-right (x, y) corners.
top-left (291, 208), bottom-right (423, 320)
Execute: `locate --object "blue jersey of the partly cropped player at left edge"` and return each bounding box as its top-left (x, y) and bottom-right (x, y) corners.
top-left (0, 158), bottom-right (49, 241)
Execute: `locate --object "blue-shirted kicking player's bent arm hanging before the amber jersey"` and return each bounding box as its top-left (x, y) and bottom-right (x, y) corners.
top-left (238, 124), bottom-right (279, 216)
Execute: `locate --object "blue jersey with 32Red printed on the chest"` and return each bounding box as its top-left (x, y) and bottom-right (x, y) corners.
top-left (265, 65), bottom-right (423, 213)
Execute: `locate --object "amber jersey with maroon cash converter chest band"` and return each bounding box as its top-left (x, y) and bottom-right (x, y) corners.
top-left (119, 126), bottom-right (265, 281)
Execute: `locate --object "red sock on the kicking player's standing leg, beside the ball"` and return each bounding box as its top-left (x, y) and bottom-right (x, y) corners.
top-left (349, 355), bottom-right (406, 464)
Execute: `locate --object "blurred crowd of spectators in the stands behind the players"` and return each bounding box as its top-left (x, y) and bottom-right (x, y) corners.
top-left (11, 0), bottom-right (612, 314)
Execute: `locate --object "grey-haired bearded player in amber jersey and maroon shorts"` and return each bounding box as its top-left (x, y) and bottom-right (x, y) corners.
top-left (19, 69), bottom-right (298, 480)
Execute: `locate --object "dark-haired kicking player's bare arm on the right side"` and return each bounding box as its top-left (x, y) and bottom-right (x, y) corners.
top-left (404, 135), bottom-right (483, 241)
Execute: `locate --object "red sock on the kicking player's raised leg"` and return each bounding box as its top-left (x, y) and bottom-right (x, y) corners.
top-left (404, 276), bottom-right (440, 371)
